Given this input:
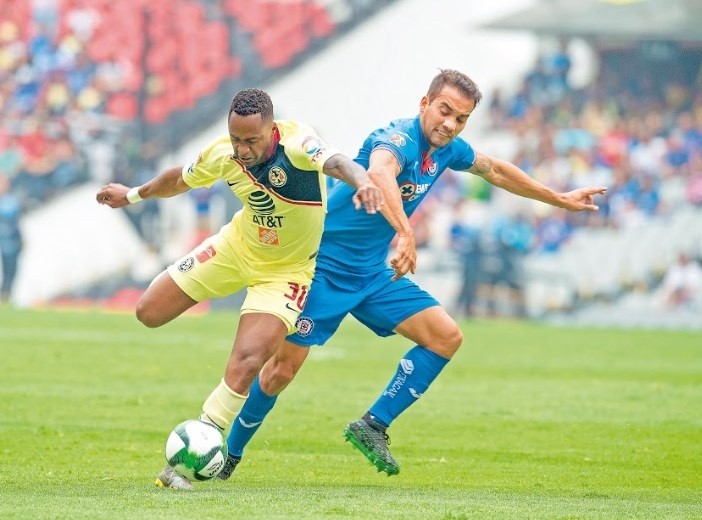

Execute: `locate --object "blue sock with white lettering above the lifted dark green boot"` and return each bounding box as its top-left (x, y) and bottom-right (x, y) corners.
top-left (368, 346), bottom-right (449, 428)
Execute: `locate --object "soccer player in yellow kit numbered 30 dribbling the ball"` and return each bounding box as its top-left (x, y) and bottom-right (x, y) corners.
top-left (97, 89), bottom-right (384, 489)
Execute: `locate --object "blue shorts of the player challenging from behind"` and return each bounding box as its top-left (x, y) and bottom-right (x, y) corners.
top-left (287, 264), bottom-right (439, 347)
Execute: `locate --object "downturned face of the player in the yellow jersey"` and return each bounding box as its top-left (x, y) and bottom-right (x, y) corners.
top-left (229, 112), bottom-right (273, 167)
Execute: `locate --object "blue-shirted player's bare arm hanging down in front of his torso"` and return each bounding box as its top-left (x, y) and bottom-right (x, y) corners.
top-left (368, 149), bottom-right (417, 280)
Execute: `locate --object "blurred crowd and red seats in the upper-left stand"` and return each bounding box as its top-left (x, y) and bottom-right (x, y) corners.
top-left (0, 0), bottom-right (390, 299)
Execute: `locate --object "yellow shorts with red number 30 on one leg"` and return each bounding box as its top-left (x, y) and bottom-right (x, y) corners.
top-left (168, 224), bottom-right (314, 332)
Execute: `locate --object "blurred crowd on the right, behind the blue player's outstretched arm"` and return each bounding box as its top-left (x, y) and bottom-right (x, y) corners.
top-left (415, 41), bottom-right (702, 315)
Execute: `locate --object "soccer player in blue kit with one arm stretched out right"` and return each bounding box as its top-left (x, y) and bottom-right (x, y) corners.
top-left (220, 70), bottom-right (606, 479)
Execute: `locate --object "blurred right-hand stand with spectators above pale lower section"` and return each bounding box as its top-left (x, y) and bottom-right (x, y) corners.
top-left (460, 0), bottom-right (702, 327)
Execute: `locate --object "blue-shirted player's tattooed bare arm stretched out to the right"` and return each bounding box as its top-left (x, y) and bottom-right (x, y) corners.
top-left (468, 152), bottom-right (607, 211)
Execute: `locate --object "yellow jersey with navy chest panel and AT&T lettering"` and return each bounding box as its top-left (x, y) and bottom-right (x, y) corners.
top-left (183, 120), bottom-right (339, 270)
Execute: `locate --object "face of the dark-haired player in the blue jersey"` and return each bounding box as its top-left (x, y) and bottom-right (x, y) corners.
top-left (419, 86), bottom-right (475, 148)
